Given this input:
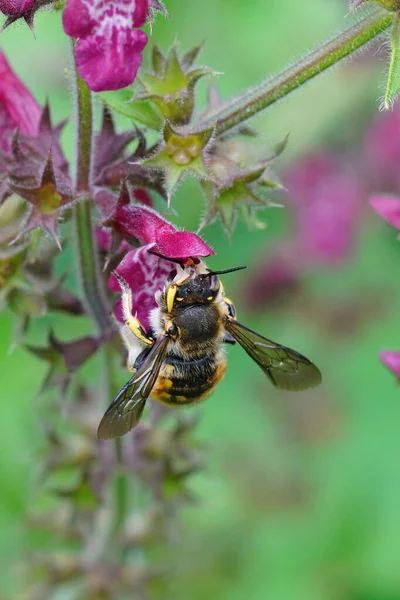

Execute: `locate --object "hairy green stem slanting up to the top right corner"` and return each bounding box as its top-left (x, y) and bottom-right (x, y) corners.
top-left (198, 9), bottom-right (393, 135)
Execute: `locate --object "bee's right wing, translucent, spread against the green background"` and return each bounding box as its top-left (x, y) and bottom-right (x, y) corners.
top-left (225, 317), bottom-right (321, 391)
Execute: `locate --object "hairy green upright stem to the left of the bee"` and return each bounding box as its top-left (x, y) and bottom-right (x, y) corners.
top-left (70, 49), bottom-right (113, 337)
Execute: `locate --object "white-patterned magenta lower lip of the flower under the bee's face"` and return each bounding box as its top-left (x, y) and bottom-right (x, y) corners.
top-left (108, 246), bottom-right (176, 328)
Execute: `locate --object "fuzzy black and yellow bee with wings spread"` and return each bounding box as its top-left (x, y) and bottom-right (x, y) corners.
top-left (98, 259), bottom-right (321, 439)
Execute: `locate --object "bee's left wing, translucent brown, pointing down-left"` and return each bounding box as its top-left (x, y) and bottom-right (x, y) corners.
top-left (97, 335), bottom-right (169, 440)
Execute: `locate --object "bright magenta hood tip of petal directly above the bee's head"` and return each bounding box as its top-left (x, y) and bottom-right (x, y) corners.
top-left (155, 231), bottom-right (215, 259)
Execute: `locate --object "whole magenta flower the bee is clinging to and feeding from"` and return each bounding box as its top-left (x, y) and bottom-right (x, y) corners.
top-left (108, 204), bottom-right (214, 327)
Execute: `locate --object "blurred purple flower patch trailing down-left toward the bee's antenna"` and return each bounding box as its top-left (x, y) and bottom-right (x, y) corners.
top-left (247, 152), bottom-right (363, 309)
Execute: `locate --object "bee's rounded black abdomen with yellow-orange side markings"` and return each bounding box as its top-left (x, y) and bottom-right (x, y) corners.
top-left (151, 351), bottom-right (226, 405)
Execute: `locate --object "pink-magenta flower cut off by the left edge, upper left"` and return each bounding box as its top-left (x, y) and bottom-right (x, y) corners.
top-left (0, 51), bottom-right (42, 153)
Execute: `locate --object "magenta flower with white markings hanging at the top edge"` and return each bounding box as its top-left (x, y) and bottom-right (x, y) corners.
top-left (63, 0), bottom-right (149, 92)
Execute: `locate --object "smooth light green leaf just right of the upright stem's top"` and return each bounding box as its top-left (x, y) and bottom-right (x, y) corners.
top-left (98, 88), bottom-right (163, 131)
